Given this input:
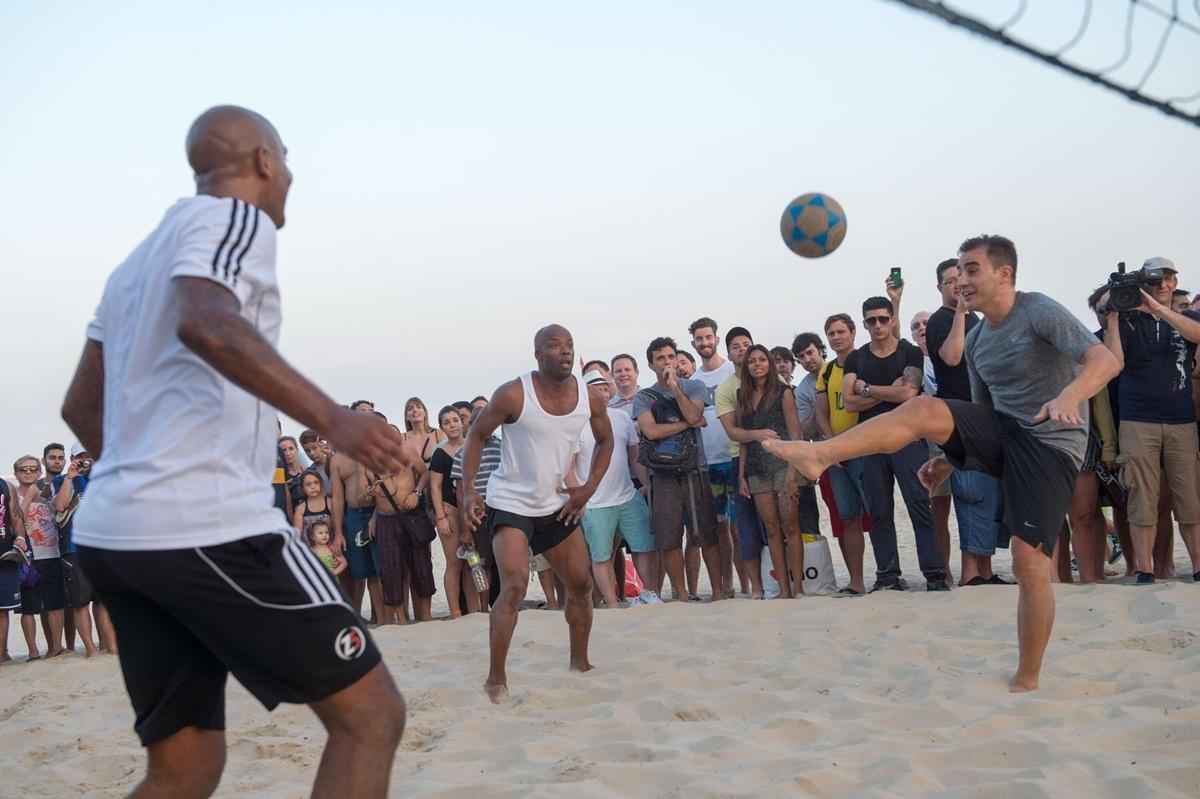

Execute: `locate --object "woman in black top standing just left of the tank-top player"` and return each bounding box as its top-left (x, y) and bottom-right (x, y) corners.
top-left (430, 405), bottom-right (481, 619)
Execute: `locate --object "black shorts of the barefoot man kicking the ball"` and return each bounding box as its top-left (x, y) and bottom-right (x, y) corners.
top-left (942, 400), bottom-right (1079, 555)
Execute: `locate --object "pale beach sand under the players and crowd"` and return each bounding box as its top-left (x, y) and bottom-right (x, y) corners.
top-left (0, 501), bottom-right (1200, 799)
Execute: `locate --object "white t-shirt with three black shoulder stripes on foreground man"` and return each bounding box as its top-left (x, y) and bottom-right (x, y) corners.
top-left (74, 196), bottom-right (287, 549)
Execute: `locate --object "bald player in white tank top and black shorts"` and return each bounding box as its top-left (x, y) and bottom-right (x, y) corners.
top-left (461, 325), bottom-right (612, 702)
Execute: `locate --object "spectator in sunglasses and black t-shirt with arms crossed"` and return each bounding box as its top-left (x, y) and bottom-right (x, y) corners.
top-left (842, 296), bottom-right (949, 591)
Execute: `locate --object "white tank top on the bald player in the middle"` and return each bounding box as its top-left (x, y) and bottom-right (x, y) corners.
top-left (487, 372), bottom-right (592, 516)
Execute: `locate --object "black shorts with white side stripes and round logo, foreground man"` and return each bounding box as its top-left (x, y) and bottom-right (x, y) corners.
top-left (79, 529), bottom-right (380, 746)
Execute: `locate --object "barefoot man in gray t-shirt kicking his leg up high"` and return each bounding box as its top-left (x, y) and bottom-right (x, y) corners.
top-left (763, 235), bottom-right (1121, 692)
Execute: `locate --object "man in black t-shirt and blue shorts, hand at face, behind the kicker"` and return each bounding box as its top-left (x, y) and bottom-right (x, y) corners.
top-left (925, 258), bottom-right (1008, 585)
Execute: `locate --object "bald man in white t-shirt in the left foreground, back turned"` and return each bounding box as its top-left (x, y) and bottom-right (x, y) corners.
top-left (62, 106), bottom-right (407, 797)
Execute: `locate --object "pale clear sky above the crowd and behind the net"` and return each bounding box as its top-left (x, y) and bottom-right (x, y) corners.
top-left (0, 0), bottom-right (1200, 458)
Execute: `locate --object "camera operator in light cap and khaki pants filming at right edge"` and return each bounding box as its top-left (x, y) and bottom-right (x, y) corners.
top-left (1100, 258), bottom-right (1200, 584)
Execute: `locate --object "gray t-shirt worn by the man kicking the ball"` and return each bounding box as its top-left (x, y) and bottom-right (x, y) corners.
top-left (966, 292), bottom-right (1097, 465)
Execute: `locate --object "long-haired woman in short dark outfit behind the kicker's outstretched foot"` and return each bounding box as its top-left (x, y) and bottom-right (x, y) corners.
top-left (738, 344), bottom-right (804, 597)
